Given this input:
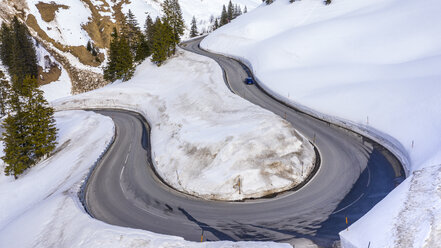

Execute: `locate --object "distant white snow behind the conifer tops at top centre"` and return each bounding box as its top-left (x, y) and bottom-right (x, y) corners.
top-left (123, 0), bottom-right (262, 32)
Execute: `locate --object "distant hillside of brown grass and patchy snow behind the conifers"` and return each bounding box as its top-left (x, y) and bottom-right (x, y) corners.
top-left (0, 0), bottom-right (260, 98)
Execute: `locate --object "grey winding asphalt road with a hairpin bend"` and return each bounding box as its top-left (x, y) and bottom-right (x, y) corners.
top-left (85, 37), bottom-right (402, 246)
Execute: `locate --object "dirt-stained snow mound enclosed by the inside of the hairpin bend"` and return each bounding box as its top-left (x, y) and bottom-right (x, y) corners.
top-left (54, 51), bottom-right (315, 200)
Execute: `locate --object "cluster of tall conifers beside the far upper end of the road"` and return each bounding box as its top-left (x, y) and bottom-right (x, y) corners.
top-left (104, 0), bottom-right (185, 81)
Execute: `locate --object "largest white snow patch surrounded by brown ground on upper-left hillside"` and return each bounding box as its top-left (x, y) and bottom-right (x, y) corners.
top-left (27, 0), bottom-right (92, 46)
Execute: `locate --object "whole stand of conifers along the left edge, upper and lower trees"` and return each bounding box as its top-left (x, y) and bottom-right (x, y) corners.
top-left (0, 17), bottom-right (57, 178)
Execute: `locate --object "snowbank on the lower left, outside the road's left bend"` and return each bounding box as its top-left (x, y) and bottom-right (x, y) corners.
top-left (0, 111), bottom-right (290, 248)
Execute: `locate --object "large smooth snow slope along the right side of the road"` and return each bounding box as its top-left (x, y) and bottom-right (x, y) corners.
top-left (202, 0), bottom-right (441, 247)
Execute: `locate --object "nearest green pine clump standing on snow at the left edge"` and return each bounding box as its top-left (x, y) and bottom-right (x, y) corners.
top-left (2, 76), bottom-right (57, 178)
